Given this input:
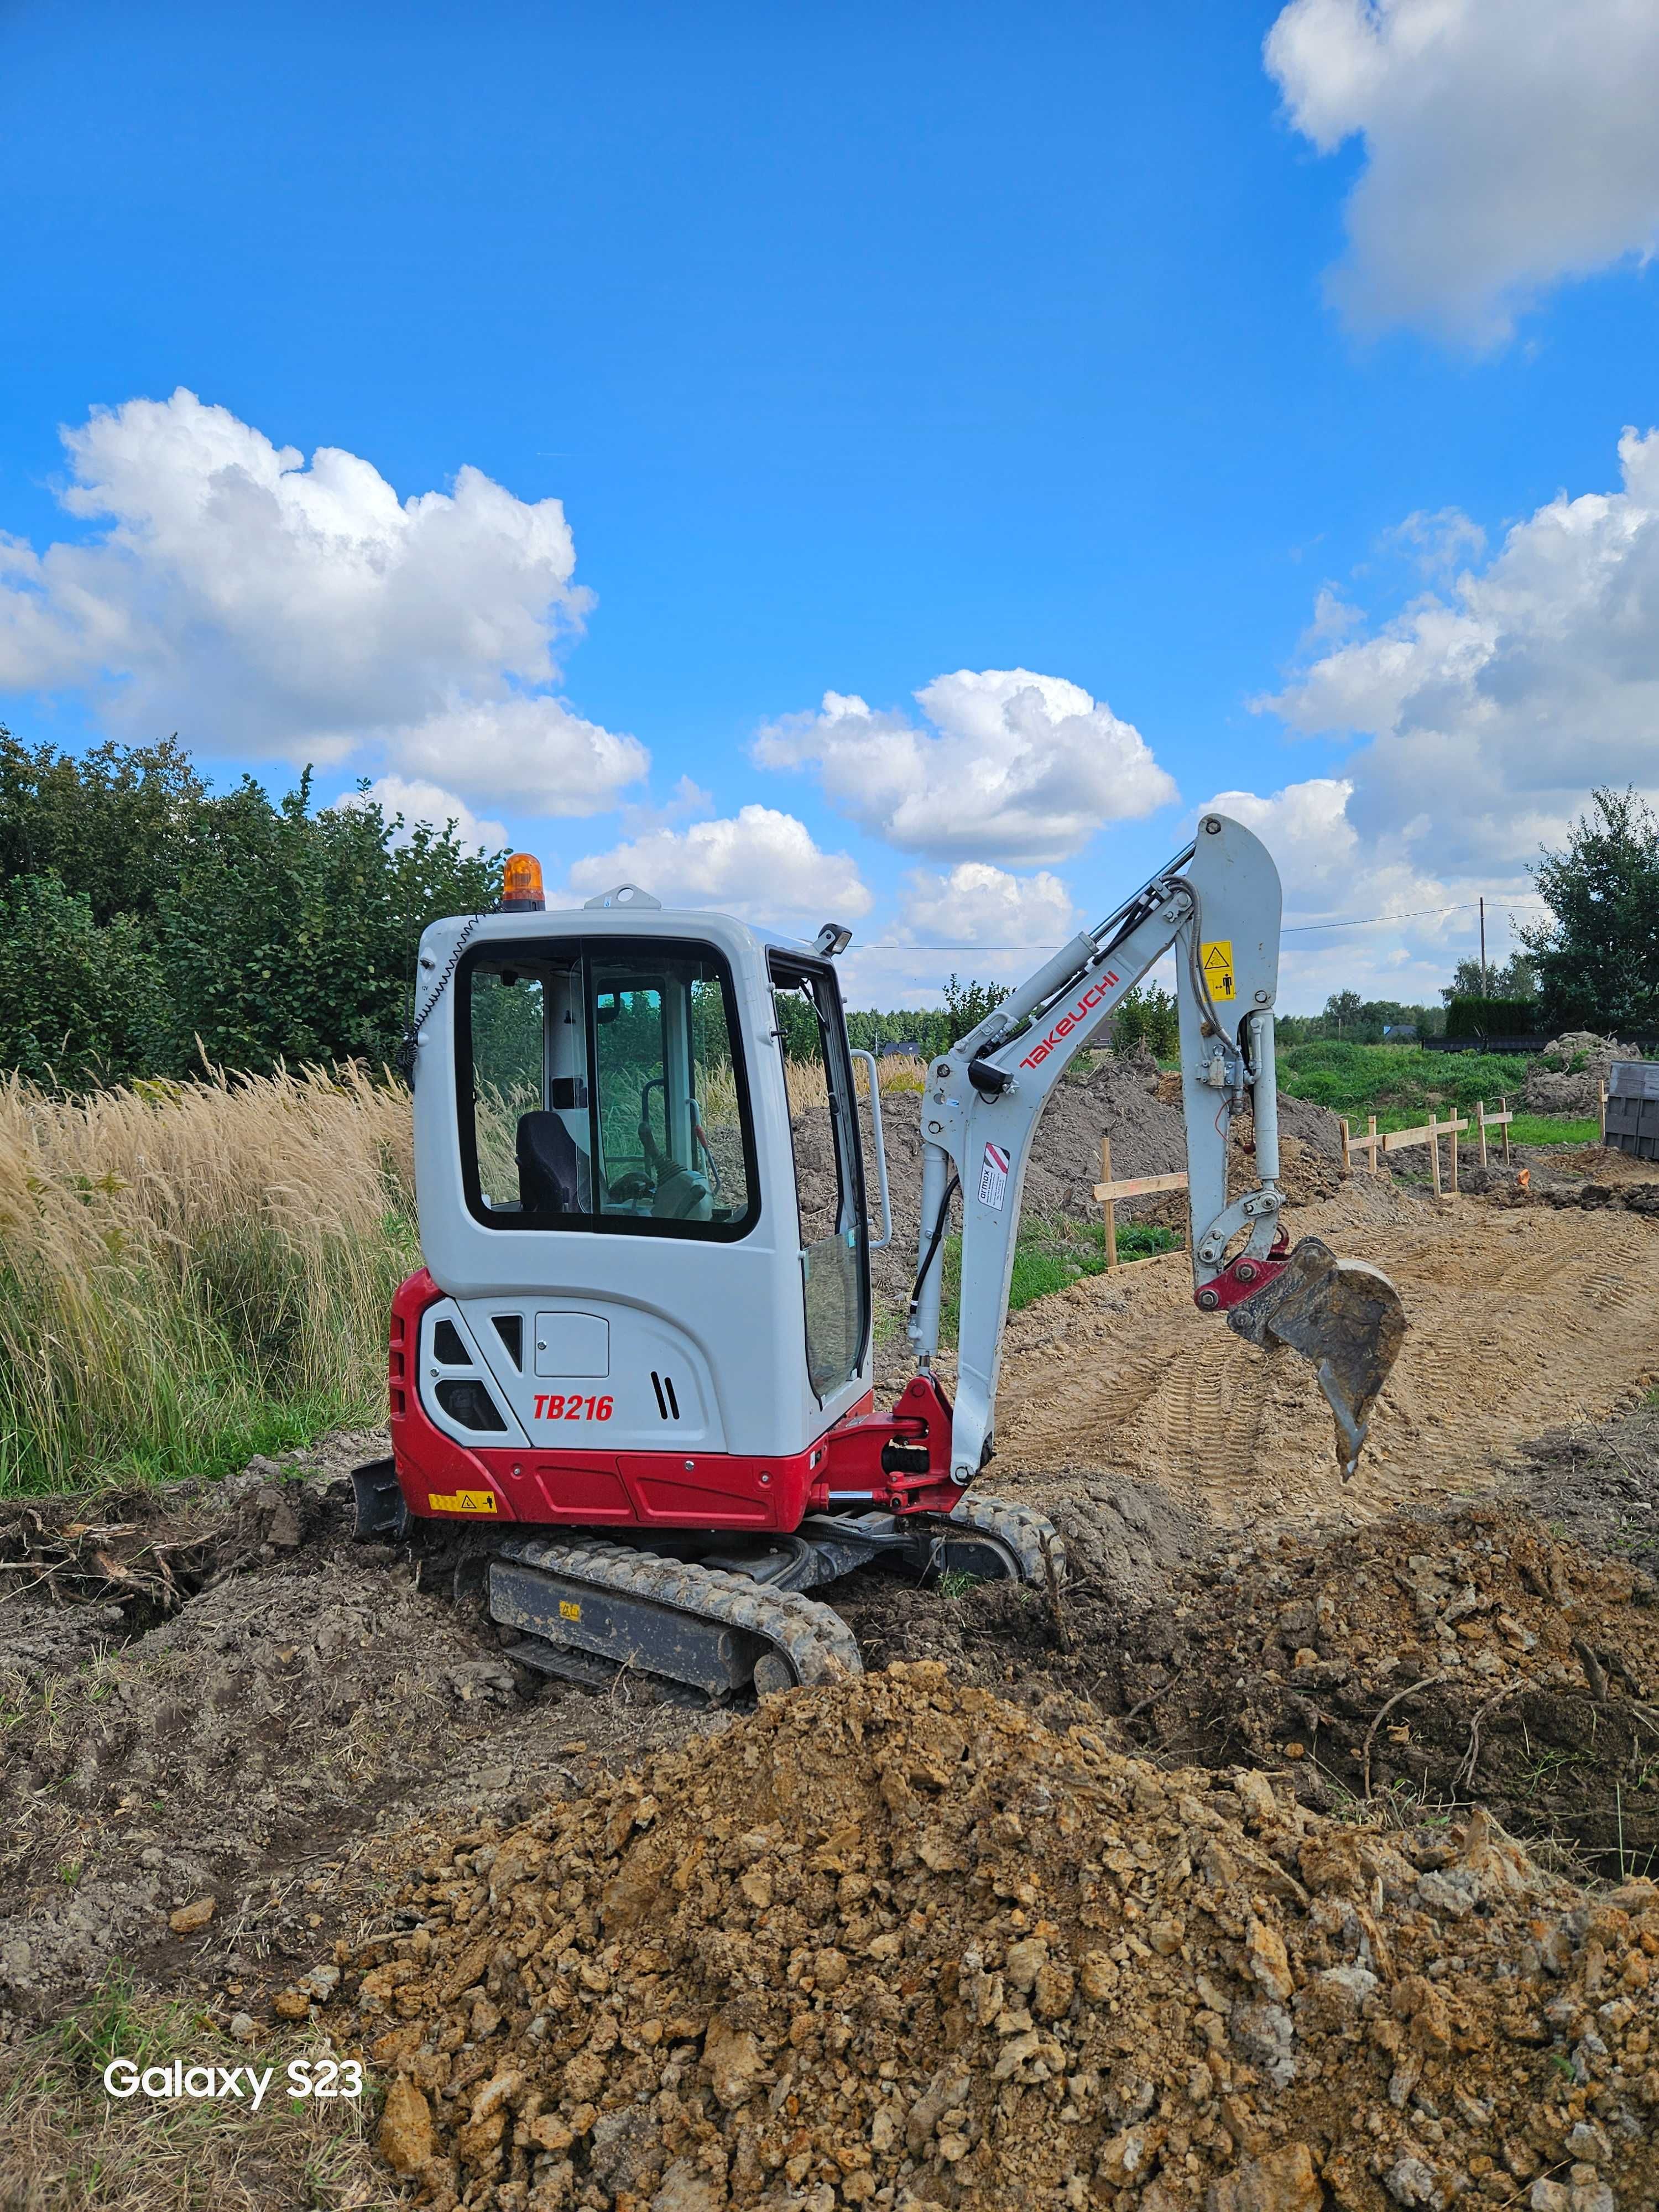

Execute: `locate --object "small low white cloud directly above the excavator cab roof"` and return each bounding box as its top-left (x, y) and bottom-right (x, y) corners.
top-left (571, 805), bottom-right (872, 933)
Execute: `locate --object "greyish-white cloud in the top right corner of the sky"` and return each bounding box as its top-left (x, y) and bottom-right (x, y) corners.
top-left (1263, 0), bottom-right (1659, 345)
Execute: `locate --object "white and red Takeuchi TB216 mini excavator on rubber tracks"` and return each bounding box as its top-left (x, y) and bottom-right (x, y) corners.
top-left (356, 814), bottom-right (1405, 1697)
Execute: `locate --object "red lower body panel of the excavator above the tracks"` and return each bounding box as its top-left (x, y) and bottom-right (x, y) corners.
top-left (387, 1267), bottom-right (962, 1531)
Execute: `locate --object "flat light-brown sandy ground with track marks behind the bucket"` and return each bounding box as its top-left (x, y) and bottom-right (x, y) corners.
top-left (993, 1175), bottom-right (1659, 1526)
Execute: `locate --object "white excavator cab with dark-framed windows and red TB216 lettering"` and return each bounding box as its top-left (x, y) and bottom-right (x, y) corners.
top-left (416, 891), bottom-right (872, 1520)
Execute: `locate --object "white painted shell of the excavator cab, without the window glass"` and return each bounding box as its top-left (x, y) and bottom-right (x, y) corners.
top-left (414, 909), bottom-right (869, 1455)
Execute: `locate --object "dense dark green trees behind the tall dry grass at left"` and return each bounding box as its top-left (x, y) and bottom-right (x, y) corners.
top-left (0, 730), bottom-right (502, 1086)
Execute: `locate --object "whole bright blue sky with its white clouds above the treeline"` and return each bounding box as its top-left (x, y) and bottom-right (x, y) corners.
top-left (0, 0), bottom-right (1659, 1009)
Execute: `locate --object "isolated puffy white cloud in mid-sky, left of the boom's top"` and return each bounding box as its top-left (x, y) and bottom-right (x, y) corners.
top-left (754, 668), bottom-right (1177, 867)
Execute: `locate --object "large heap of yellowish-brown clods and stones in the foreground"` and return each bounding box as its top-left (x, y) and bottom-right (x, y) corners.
top-left (338, 1668), bottom-right (1659, 2212)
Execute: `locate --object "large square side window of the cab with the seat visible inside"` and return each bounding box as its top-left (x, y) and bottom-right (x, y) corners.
top-left (460, 940), bottom-right (759, 1239)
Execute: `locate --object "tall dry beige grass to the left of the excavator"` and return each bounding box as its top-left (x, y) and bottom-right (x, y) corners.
top-left (0, 1071), bottom-right (418, 1493)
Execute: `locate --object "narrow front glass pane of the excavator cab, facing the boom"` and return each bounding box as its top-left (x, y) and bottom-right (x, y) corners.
top-left (772, 958), bottom-right (869, 1400)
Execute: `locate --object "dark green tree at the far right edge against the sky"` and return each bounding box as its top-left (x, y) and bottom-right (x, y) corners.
top-left (1520, 787), bottom-right (1659, 1037)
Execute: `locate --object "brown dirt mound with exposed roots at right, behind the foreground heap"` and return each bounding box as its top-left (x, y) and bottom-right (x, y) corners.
top-left (1150, 1506), bottom-right (1659, 1876)
